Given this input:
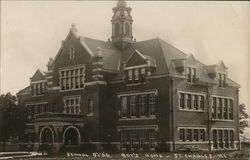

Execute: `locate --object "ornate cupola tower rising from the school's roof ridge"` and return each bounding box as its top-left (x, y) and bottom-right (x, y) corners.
top-left (111, 0), bottom-right (133, 49)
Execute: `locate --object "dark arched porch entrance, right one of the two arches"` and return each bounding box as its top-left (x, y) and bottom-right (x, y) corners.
top-left (63, 126), bottom-right (81, 145)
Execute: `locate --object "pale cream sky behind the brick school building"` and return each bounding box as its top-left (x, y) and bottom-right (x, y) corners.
top-left (0, 1), bottom-right (250, 137)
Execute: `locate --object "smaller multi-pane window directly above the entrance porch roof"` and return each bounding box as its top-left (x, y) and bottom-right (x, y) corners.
top-left (64, 97), bottom-right (81, 114)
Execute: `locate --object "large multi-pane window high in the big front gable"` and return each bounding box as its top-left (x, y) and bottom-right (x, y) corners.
top-left (60, 67), bottom-right (85, 91)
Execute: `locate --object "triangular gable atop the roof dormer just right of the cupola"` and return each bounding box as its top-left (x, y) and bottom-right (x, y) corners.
top-left (126, 50), bottom-right (149, 67)
